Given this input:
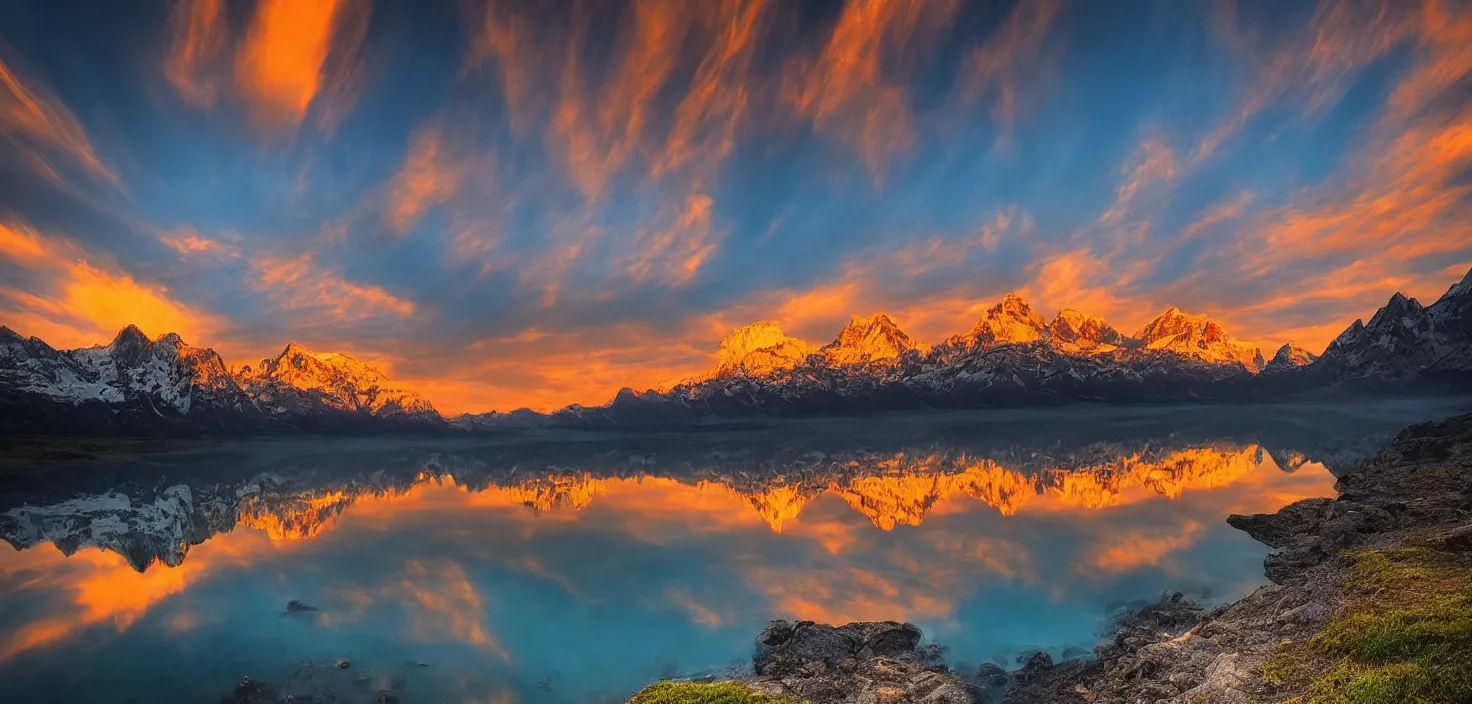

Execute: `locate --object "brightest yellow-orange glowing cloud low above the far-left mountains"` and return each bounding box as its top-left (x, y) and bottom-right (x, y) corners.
top-left (0, 217), bottom-right (224, 348)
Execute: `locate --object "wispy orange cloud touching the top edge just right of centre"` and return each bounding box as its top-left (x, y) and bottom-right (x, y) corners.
top-left (782, 0), bottom-right (960, 178)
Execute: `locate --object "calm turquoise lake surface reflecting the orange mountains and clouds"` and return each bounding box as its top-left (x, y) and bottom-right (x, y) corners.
top-left (0, 402), bottom-right (1456, 704)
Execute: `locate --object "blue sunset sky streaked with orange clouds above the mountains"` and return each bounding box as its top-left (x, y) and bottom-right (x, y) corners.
top-left (0, 0), bottom-right (1472, 414)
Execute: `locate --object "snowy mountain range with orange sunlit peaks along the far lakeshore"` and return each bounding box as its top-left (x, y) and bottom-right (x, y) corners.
top-left (0, 266), bottom-right (1472, 434)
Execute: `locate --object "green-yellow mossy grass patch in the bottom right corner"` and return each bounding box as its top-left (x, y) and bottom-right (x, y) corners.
top-left (1262, 548), bottom-right (1472, 704)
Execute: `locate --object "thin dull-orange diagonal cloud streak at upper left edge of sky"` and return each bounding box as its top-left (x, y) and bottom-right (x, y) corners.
top-left (0, 50), bottom-right (121, 187)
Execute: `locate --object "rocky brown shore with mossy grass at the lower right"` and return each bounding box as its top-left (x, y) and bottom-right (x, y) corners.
top-left (662, 415), bottom-right (1472, 704)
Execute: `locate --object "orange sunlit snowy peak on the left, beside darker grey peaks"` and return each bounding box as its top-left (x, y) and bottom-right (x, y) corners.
top-left (238, 342), bottom-right (439, 420)
